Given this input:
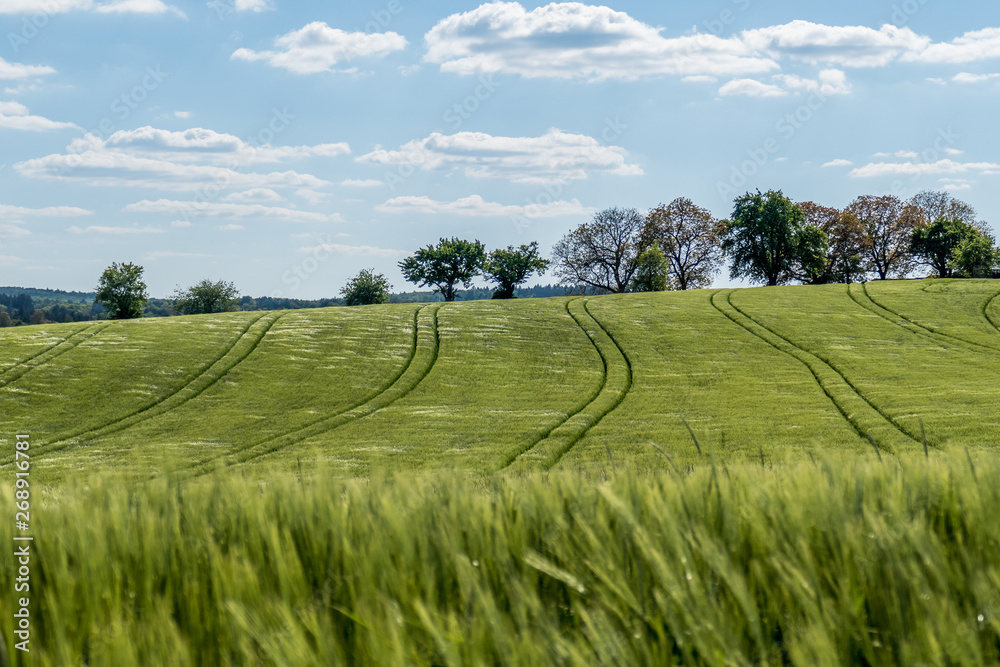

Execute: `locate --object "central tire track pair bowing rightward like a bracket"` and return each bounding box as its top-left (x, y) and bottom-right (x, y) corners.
top-left (501, 299), bottom-right (632, 470)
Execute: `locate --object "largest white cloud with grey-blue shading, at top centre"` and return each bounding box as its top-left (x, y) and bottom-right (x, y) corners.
top-left (424, 2), bottom-right (778, 81)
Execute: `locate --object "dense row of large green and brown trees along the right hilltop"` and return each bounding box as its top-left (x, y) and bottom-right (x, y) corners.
top-left (553, 190), bottom-right (1000, 292)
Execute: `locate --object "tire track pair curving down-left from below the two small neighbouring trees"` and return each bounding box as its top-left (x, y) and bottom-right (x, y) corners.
top-left (193, 304), bottom-right (441, 475)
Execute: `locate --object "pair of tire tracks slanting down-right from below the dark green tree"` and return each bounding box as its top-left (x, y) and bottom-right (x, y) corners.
top-left (710, 290), bottom-right (920, 452)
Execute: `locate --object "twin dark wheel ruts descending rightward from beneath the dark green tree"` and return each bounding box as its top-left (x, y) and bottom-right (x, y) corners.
top-left (710, 290), bottom-right (920, 451)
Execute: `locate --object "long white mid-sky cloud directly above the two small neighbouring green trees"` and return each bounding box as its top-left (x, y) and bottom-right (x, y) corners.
top-left (357, 128), bottom-right (643, 183)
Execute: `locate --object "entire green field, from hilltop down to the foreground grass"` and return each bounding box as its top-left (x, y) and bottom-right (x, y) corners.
top-left (0, 280), bottom-right (1000, 665)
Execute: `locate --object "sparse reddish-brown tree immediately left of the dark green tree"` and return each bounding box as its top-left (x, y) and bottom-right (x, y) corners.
top-left (643, 197), bottom-right (724, 290)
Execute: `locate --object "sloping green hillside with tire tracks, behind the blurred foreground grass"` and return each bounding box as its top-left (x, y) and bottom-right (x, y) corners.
top-left (0, 280), bottom-right (1000, 476)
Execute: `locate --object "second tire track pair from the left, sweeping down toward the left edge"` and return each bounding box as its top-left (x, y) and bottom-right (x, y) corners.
top-left (32, 312), bottom-right (286, 454)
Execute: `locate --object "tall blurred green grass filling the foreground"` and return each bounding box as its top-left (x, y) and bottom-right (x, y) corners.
top-left (0, 449), bottom-right (1000, 667)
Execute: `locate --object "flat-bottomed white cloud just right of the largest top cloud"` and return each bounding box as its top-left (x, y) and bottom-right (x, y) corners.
top-left (741, 21), bottom-right (931, 67)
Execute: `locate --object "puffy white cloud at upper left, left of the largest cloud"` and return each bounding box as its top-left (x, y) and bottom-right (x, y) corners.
top-left (231, 21), bottom-right (407, 74)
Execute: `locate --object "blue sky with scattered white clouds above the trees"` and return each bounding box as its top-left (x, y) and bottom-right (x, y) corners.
top-left (0, 0), bottom-right (1000, 298)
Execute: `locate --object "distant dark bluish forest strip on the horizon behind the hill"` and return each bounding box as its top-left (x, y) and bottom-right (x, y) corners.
top-left (0, 285), bottom-right (568, 327)
